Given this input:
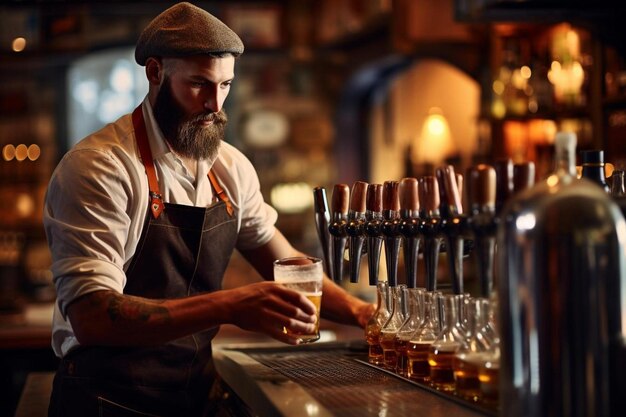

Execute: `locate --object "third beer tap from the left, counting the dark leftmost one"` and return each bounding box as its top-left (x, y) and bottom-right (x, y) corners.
top-left (346, 181), bottom-right (368, 283)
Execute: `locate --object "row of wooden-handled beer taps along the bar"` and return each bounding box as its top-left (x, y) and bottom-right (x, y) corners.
top-left (313, 159), bottom-right (535, 297)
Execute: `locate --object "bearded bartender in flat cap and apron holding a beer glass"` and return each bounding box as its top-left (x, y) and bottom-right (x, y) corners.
top-left (44, 3), bottom-right (373, 417)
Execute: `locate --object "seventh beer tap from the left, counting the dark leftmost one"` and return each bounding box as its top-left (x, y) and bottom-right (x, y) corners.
top-left (418, 176), bottom-right (441, 291)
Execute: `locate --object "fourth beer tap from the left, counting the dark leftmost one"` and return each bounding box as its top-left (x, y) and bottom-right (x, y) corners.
top-left (365, 184), bottom-right (383, 285)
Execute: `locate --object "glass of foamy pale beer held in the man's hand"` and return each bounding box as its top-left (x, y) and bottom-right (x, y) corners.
top-left (274, 256), bottom-right (324, 343)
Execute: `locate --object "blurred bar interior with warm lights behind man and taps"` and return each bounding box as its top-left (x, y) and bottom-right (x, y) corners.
top-left (0, 0), bottom-right (626, 415)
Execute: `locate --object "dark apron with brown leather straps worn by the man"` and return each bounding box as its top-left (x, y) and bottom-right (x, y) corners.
top-left (49, 106), bottom-right (237, 417)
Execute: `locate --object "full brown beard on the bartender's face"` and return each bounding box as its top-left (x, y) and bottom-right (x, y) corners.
top-left (152, 77), bottom-right (228, 159)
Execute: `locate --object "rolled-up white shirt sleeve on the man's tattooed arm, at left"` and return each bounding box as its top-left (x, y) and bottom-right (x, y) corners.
top-left (44, 145), bottom-right (137, 317)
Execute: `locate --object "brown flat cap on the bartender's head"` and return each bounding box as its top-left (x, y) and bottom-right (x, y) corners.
top-left (135, 2), bottom-right (243, 65)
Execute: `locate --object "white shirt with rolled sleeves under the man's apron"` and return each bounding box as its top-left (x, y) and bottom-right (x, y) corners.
top-left (43, 99), bottom-right (277, 356)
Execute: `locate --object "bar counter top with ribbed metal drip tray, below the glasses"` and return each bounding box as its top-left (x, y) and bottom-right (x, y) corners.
top-left (215, 342), bottom-right (497, 417)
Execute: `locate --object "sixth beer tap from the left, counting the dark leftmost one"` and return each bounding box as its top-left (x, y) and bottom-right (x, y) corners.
top-left (398, 178), bottom-right (420, 288)
